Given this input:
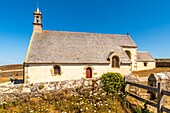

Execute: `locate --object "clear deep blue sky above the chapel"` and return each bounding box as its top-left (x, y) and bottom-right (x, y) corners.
top-left (0, 0), bottom-right (170, 65)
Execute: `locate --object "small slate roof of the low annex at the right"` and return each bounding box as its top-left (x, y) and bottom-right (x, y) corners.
top-left (137, 52), bottom-right (155, 62)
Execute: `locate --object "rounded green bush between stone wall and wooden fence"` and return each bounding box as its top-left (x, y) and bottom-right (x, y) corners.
top-left (102, 72), bottom-right (124, 94)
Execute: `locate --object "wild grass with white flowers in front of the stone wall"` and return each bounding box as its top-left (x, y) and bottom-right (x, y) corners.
top-left (0, 89), bottom-right (131, 113)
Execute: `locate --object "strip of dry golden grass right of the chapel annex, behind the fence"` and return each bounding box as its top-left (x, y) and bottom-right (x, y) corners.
top-left (132, 67), bottom-right (170, 77)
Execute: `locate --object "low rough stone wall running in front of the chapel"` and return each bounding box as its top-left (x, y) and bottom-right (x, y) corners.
top-left (0, 78), bottom-right (103, 104)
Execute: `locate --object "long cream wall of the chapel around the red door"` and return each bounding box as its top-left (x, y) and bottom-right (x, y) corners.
top-left (25, 64), bottom-right (131, 83)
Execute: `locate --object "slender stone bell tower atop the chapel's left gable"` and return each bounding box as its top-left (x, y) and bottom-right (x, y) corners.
top-left (33, 6), bottom-right (43, 32)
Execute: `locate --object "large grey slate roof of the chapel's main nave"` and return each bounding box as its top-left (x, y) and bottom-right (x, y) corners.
top-left (25, 30), bottom-right (137, 63)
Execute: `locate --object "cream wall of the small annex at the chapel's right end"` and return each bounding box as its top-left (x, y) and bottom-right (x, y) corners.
top-left (137, 62), bottom-right (156, 71)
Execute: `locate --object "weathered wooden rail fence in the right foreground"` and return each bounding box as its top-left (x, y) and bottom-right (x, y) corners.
top-left (125, 81), bottom-right (170, 113)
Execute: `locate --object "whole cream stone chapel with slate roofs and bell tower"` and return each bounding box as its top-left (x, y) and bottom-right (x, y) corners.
top-left (24, 8), bottom-right (155, 83)
